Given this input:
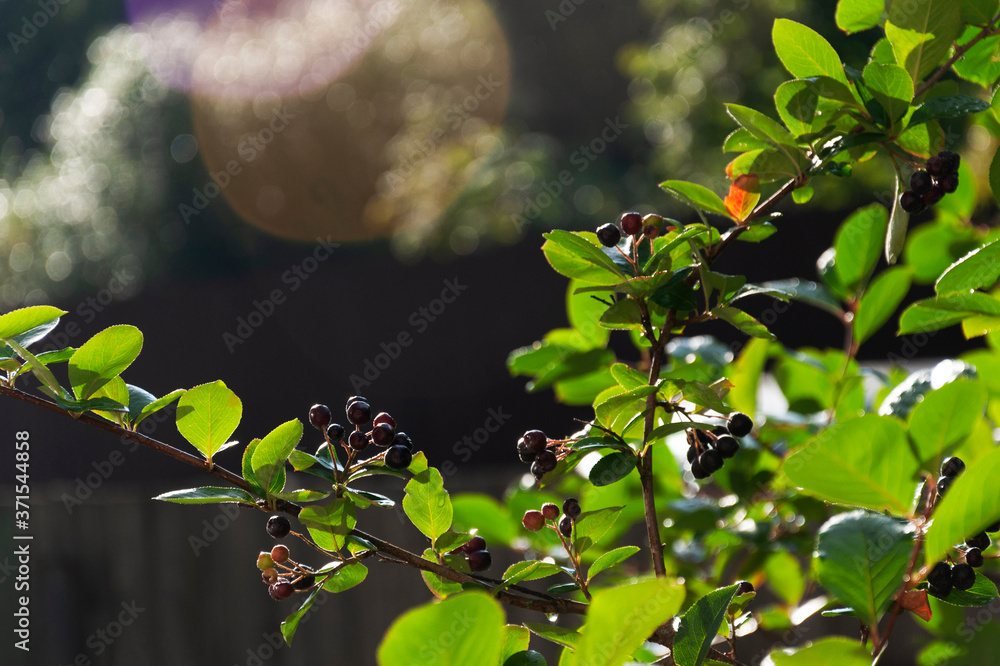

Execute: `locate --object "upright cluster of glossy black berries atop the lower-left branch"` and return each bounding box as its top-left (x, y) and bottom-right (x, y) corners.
top-left (309, 395), bottom-right (413, 469)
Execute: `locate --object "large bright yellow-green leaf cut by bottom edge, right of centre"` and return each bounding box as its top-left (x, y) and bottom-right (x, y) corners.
top-left (570, 578), bottom-right (684, 666)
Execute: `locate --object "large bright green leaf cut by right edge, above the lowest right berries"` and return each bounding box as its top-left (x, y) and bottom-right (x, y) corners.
top-left (924, 449), bottom-right (1000, 565)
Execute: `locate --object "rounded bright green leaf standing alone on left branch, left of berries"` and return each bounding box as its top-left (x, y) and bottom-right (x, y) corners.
top-left (177, 380), bottom-right (240, 462)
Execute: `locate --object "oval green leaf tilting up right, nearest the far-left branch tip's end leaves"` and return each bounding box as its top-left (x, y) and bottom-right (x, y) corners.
top-left (69, 325), bottom-right (142, 400)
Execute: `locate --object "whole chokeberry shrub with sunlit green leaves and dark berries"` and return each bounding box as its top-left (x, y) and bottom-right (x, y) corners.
top-left (0, 0), bottom-right (1000, 666)
